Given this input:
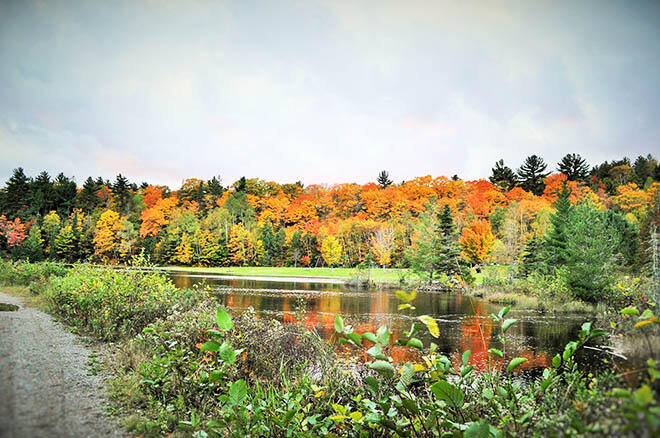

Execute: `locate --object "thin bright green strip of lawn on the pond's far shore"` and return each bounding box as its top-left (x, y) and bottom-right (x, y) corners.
top-left (160, 266), bottom-right (406, 283)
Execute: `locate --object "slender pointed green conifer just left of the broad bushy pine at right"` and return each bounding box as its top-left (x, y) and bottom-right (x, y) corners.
top-left (543, 182), bottom-right (573, 267)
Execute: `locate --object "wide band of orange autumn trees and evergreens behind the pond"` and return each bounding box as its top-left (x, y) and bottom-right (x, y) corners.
top-left (0, 154), bottom-right (660, 302)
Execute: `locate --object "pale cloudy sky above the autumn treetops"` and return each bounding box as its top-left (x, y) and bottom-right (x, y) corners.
top-left (0, 0), bottom-right (660, 188)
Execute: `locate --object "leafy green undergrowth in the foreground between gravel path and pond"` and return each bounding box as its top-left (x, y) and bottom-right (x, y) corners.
top-left (0, 258), bottom-right (660, 437)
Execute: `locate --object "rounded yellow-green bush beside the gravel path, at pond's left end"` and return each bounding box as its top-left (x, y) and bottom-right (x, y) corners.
top-left (45, 265), bottom-right (202, 341)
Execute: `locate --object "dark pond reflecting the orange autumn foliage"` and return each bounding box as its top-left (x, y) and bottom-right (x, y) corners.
top-left (169, 271), bottom-right (620, 370)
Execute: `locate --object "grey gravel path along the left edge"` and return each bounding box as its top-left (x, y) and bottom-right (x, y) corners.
top-left (0, 292), bottom-right (123, 438)
